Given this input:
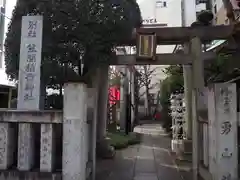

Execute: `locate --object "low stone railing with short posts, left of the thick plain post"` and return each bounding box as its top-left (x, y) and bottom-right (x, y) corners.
top-left (0, 109), bottom-right (91, 180)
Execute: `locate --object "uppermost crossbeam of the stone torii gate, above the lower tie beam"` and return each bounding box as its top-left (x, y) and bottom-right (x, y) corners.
top-left (121, 24), bottom-right (240, 46)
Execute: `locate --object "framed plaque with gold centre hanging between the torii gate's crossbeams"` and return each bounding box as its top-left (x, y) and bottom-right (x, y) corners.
top-left (137, 34), bottom-right (156, 59)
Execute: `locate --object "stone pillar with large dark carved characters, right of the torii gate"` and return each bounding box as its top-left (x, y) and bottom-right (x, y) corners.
top-left (208, 83), bottom-right (238, 180)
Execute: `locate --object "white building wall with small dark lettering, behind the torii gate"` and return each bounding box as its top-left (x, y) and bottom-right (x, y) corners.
top-left (138, 0), bottom-right (182, 97)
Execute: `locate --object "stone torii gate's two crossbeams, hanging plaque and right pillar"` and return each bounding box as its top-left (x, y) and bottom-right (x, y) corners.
top-left (112, 24), bottom-right (239, 180)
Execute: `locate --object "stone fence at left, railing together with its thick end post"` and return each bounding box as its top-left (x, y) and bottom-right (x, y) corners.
top-left (0, 82), bottom-right (94, 180)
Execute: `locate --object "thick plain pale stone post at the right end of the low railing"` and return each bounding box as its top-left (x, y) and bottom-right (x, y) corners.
top-left (62, 82), bottom-right (88, 180)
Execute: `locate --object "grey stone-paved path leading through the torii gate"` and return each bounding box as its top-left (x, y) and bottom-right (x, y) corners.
top-left (96, 124), bottom-right (191, 180)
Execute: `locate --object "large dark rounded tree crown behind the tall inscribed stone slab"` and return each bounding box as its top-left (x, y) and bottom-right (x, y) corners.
top-left (5, 0), bottom-right (141, 88)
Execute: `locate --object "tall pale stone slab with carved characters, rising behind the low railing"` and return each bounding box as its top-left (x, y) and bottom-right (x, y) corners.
top-left (17, 16), bottom-right (43, 110)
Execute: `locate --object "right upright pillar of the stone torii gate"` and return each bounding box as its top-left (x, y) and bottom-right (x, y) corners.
top-left (190, 37), bottom-right (206, 180)
